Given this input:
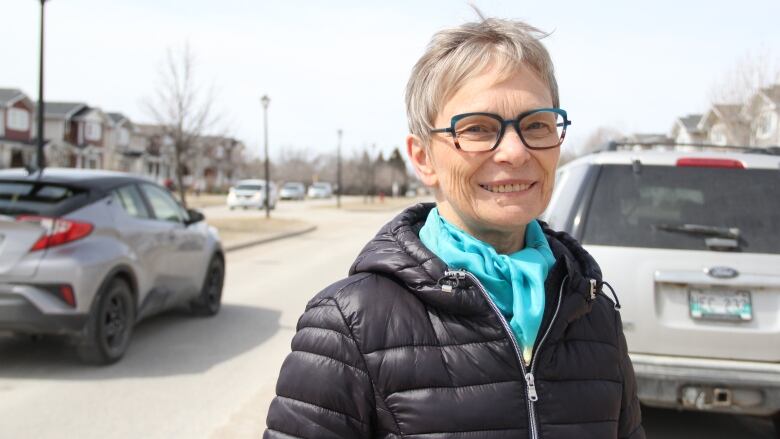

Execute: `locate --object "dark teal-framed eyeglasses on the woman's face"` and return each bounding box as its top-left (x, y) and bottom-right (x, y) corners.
top-left (431, 108), bottom-right (571, 152)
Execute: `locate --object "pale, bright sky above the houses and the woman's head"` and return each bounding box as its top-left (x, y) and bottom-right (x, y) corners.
top-left (0, 0), bottom-right (780, 159)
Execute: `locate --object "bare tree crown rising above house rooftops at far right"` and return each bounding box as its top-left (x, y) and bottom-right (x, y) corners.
top-left (709, 51), bottom-right (780, 103)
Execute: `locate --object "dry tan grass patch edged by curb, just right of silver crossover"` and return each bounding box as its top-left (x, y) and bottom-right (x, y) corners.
top-left (206, 217), bottom-right (317, 252)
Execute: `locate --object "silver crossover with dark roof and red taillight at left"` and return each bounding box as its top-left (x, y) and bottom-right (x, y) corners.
top-left (0, 168), bottom-right (225, 364)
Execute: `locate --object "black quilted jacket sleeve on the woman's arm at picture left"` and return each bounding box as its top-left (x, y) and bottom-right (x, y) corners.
top-left (263, 298), bottom-right (374, 439)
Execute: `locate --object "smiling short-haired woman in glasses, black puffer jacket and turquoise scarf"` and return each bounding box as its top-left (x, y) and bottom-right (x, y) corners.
top-left (265, 19), bottom-right (644, 439)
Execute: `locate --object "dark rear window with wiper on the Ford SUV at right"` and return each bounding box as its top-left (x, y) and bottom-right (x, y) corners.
top-left (582, 165), bottom-right (780, 254)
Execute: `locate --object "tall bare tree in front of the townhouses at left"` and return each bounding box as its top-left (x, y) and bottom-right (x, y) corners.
top-left (145, 44), bottom-right (216, 206)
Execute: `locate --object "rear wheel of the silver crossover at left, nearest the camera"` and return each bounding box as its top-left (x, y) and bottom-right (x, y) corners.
top-left (77, 278), bottom-right (135, 364)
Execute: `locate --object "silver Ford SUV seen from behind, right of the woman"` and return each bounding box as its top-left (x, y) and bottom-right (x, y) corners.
top-left (543, 147), bottom-right (780, 426)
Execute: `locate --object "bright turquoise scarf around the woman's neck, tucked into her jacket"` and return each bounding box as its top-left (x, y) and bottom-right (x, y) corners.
top-left (420, 208), bottom-right (555, 362)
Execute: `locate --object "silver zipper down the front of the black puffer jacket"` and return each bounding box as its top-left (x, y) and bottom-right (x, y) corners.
top-left (444, 269), bottom-right (568, 439)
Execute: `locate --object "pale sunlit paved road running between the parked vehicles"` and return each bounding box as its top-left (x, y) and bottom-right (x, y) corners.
top-left (0, 201), bottom-right (775, 439)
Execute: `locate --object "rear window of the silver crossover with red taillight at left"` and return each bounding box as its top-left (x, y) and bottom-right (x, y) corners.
top-left (0, 181), bottom-right (87, 216)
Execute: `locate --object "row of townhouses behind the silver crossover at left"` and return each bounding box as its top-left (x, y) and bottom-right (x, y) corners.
top-left (0, 88), bottom-right (246, 191)
